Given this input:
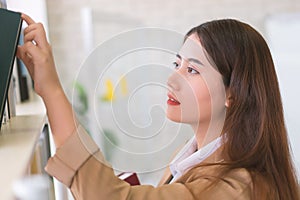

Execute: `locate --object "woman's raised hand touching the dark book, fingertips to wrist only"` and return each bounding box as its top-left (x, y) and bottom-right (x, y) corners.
top-left (17, 14), bottom-right (61, 99)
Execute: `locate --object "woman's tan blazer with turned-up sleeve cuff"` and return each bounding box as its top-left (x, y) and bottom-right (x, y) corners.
top-left (45, 126), bottom-right (251, 200)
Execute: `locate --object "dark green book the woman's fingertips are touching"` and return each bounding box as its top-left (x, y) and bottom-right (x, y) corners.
top-left (0, 8), bottom-right (22, 129)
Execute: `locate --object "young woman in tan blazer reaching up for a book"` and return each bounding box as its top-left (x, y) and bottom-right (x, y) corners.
top-left (17, 15), bottom-right (299, 200)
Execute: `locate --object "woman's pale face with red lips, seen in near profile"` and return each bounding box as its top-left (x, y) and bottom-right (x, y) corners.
top-left (167, 34), bottom-right (225, 132)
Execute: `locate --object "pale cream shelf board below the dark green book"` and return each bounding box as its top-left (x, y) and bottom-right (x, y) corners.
top-left (0, 115), bottom-right (47, 200)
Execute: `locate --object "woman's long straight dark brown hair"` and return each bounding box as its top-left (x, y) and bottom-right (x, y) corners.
top-left (187, 19), bottom-right (299, 200)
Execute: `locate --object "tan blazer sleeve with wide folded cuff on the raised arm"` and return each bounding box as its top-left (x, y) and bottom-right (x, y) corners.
top-left (45, 125), bottom-right (193, 200)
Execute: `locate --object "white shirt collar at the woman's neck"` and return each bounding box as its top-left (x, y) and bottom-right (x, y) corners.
top-left (170, 136), bottom-right (222, 183)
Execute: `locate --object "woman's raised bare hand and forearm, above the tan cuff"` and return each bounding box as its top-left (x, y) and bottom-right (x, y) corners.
top-left (17, 14), bottom-right (76, 147)
